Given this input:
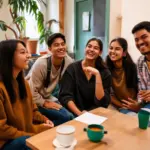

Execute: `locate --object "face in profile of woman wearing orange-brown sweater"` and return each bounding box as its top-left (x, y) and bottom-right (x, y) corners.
top-left (13, 43), bottom-right (31, 71)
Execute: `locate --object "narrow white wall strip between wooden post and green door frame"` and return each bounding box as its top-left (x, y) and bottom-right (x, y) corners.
top-left (64, 0), bottom-right (74, 52)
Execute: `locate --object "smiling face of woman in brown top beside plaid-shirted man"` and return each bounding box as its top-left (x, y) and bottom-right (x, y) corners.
top-left (108, 41), bottom-right (124, 62)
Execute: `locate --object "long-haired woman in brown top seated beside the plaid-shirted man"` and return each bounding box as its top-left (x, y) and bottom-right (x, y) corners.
top-left (106, 37), bottom-right (139, 114)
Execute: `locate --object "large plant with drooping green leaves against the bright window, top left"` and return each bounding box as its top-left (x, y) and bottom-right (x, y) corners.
top-left (0, 0), bottom-right (46, 53)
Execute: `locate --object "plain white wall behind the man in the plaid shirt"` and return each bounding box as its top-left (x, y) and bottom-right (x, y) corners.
top-left (122, 0), bottom-right (150, 62)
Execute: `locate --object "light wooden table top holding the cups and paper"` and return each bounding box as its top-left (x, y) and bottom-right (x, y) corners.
top-left (26, 108), bottom-right (150, 150)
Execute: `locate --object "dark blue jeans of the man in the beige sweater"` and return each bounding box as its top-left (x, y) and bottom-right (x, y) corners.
top-left (38, 106), bottom-right (74, 126)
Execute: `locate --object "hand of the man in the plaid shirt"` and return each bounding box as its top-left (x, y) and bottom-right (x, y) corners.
top-left (138, 90), bottom-right (150, 102)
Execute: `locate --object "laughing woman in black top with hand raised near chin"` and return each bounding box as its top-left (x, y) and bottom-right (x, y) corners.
top-left (59, 38), bottom-right (111, 116)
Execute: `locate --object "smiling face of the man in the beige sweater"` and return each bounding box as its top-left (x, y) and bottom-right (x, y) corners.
top-left (49, 38), bottom-right (66, 58)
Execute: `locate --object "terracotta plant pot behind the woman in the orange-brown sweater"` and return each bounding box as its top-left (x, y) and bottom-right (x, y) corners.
top-left (26, 39), bottom-right (38, 54)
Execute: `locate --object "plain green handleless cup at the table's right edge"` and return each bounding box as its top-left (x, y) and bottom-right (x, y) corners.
top-left (138, 109), bottom-right (150, 129)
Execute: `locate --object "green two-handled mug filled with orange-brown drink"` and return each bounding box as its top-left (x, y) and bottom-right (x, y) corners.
top-left (84, 124), bottom-right (107, 142)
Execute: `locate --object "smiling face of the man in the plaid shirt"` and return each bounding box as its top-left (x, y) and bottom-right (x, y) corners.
top-left (134, 29), bottom-right (150, 55)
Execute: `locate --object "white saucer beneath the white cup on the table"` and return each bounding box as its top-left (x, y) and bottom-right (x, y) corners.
top-left (53, 138), bottom-right (77, 150)
